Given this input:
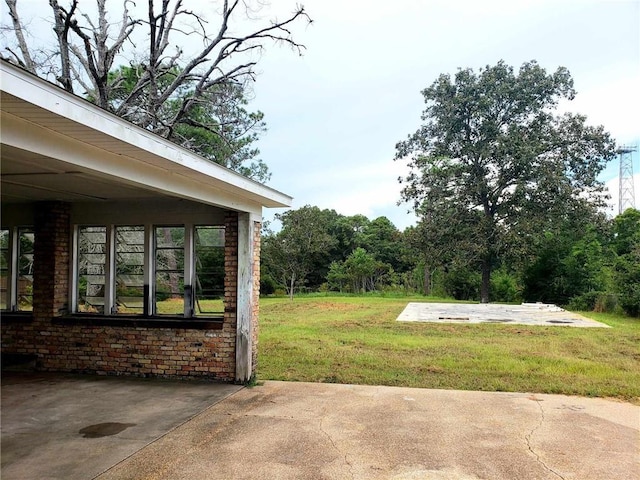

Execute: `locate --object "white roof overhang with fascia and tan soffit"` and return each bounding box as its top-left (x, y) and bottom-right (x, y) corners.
top-left (0, 61), bottom-right (292, 214)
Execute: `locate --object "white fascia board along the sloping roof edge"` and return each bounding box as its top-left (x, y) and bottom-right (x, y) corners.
top-left (0, 61), bottom-right (292, 207)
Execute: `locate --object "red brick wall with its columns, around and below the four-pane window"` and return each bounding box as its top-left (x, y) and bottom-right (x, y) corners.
top-left (2, 203), bottom-right (242, 382)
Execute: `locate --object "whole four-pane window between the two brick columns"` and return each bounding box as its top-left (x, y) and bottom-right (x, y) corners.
top-left (73, 225), bottom-right (225, 317)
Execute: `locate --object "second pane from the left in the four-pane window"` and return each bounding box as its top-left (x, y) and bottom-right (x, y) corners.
top-left (116, 225), bottom-right (144, 313)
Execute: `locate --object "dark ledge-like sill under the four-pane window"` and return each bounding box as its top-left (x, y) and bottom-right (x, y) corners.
top-left (52, 314), bottom-right (224, 330)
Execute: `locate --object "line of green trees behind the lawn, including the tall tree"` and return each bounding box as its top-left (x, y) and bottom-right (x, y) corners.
top-left (263, 61), bottom-right (640, 316)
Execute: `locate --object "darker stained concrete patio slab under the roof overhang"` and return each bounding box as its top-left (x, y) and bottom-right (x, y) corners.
top-left (1, 372), bottom-right (242, 480)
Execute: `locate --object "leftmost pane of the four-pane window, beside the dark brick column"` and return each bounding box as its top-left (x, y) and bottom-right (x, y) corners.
top-left (78, 227), bottom-right (107, 313)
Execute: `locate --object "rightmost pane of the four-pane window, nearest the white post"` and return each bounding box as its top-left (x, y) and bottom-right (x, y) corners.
top-left (195, 226), bottom-right (224, 315)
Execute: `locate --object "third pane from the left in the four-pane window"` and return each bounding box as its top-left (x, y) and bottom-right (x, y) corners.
top-left (155, 227), bottom-right (184, 315)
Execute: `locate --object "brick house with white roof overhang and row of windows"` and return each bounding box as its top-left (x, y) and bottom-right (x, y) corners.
top-left (0, 61), bottom-right (291, 382)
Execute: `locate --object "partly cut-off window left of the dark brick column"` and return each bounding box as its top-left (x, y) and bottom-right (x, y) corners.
top-left (0, 227), bottom-right (35, 312)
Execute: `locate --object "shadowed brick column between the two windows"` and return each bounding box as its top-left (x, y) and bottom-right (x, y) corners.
top-left (33, 202), bottom-right (71, 321)
